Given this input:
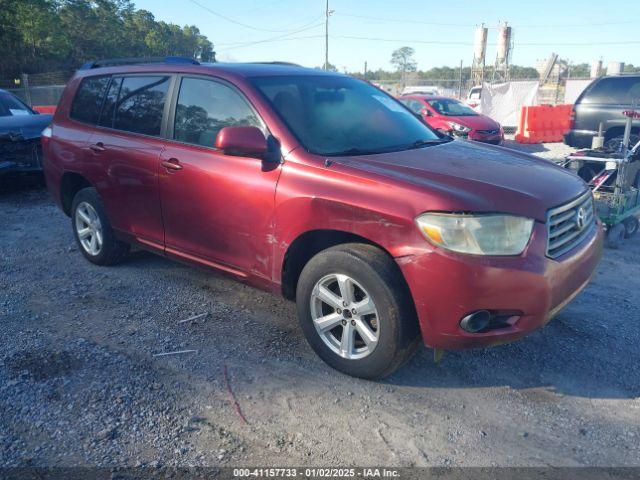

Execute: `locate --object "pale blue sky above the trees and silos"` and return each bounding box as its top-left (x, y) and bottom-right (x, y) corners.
top-left (134, 0), bottom-right (640, 71)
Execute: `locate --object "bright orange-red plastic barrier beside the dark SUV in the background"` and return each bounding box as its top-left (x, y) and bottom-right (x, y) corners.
top-left (516, 105), bottom-right (572, 143)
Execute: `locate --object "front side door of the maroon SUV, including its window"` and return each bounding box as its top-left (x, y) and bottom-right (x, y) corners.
top-left (160, 77), bottom-right (280, 278)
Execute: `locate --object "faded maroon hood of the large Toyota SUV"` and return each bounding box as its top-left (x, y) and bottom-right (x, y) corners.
top-left (333, 140), bottom-right (587, 222)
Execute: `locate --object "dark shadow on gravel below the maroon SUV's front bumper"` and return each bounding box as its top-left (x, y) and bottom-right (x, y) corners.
top-left (386, 307), bottom-right (640, 399)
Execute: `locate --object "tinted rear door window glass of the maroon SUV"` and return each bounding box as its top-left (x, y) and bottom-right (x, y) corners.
top-left (110, 76), bottom-right (169, 136)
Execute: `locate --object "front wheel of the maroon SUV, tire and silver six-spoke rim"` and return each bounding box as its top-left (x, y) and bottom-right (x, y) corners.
top-left (296, 243), bottom-right (420, 380)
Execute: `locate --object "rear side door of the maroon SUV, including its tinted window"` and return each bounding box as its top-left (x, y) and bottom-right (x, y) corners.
top-left (88, 73), bottom-right (173, 248)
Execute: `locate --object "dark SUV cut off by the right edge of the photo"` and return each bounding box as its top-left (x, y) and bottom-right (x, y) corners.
top-left (564, 75), bottom-right (640, 150)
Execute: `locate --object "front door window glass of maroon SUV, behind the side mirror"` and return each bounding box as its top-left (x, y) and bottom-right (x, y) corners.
top-left (173, 78), bottom-right (262, 147)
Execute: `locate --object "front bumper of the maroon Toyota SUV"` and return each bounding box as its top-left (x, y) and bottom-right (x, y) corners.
top-left (396, 223), bottom-right (603, 350)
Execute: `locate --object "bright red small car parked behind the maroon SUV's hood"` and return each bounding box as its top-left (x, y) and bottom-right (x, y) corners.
top-left (400, 95), bottom-right (504, 145)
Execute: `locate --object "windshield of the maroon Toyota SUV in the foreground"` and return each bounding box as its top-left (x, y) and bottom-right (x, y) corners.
top-left (251, 75), bottom-right (444, 155)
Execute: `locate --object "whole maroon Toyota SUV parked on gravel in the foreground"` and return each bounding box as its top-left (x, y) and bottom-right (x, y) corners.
top-left (43, 58), bottom-right (602, 378)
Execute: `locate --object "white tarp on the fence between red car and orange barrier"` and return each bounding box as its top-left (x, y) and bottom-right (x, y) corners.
top-left (478, 80), bottom-right (538, 127)
